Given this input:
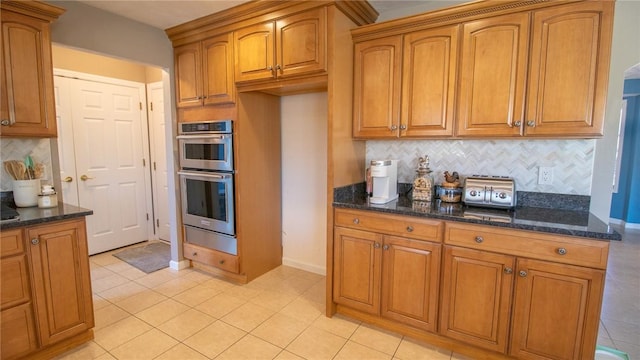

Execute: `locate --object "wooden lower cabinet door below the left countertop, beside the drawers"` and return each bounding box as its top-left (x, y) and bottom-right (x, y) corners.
top-left (27, 219), bottom-right (94, 346)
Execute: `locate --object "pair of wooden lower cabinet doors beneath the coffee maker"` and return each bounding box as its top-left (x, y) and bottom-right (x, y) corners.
top-left (333, 227), bottom-right (440, 331)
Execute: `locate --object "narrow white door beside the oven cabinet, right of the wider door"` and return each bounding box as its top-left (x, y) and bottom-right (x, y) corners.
top-left (147, 81), bottom-right (170, 241)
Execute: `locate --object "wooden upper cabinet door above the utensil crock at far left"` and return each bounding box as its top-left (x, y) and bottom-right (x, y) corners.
top-left (0, 10), bottom-right (57, 137)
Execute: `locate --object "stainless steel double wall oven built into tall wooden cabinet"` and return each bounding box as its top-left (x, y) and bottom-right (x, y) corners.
top-left (178, 120), bottom-right (238, 255)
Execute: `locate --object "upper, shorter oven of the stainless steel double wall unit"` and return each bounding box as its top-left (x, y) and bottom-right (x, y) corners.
top-left (177, 120), bottom-right (233, 171)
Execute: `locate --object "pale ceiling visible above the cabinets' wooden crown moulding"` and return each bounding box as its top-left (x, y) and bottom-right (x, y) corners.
top-left (75, 0), bottom-right (424, 30)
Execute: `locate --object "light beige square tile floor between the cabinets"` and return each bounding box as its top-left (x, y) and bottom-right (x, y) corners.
top-left (58, 231), bottom-right (640, 360)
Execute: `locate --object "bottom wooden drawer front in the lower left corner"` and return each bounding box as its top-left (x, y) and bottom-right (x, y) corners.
top-left (0, 302), bottom-right (38, 359)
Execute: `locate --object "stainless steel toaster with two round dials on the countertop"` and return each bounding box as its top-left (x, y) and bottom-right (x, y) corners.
top-left (462, 175), bottom-right (516, 209)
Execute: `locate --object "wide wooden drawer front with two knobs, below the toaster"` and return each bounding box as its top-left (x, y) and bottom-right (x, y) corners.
top-left (444, 222), bottom-right (609, 269)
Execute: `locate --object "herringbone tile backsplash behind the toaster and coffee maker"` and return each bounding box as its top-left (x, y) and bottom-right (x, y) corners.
top-left (366, 140), bottom-right (595, 195)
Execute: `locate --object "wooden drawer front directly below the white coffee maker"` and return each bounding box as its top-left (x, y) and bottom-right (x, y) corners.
top-left (334, 209), bottom-right (444, 242)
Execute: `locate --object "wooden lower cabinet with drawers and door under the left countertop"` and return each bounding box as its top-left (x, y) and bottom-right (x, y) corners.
top-left (0, 218), bottom-right (94, 360)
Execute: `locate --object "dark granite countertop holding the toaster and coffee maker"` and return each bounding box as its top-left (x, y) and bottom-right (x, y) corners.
top-left (333, 186), bottom-right (621, 240)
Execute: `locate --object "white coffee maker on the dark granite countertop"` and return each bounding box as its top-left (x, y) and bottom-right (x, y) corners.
top-left (369, 160), bottom-right (398, 204)
